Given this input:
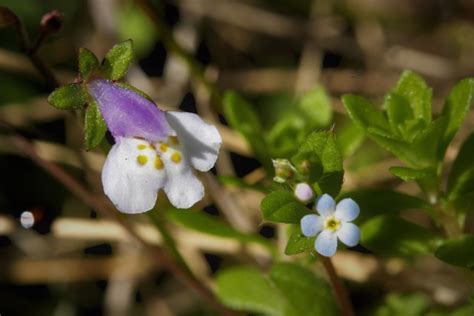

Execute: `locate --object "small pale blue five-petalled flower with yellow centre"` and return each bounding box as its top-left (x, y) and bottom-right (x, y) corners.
top-left (301, 194), bottom-right (360, 257)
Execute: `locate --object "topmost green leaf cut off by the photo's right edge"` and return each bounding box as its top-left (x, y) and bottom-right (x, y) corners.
top-left (441, 78), bottom-right (474, 152)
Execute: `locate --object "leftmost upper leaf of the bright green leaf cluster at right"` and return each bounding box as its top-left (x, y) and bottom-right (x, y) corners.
top-left (342, 94), bottom-right (392, 137)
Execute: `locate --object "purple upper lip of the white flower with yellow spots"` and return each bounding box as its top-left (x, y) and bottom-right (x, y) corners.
top-left (88, 79), bottom-right (172, 143)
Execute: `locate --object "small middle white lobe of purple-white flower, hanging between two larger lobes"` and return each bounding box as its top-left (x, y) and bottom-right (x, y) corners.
top-left (161, 147), bottom-right (204, 208)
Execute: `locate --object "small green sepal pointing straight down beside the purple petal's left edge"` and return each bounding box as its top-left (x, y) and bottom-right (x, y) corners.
top-left (84, 101), bottom-right (107, 150)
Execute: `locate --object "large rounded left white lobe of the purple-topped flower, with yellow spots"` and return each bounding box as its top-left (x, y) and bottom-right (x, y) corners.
top-left (102, 137), bottom-right (166, 214)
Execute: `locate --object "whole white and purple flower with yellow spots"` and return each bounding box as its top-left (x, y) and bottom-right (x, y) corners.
top-left (88, 79), bottom-right (222, 214)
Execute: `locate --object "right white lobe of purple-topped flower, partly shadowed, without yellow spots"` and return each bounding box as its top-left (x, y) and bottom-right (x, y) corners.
top-left (165, 111), bottom-right (222, 171)
